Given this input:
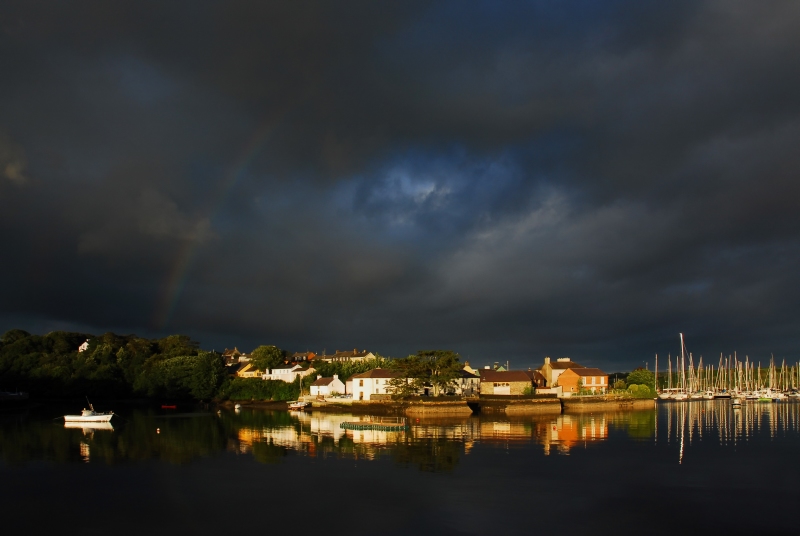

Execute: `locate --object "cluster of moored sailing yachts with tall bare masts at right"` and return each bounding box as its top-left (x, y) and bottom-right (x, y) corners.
top-left (656, 333), bottom-right (800, 403)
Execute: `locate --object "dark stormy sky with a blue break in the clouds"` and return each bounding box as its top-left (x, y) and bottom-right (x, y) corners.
top-left (0, 0), bottom-right (800, 370)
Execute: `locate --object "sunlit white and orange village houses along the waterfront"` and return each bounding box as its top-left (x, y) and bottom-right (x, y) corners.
top-left (223, 348), bottom-right (608, 403)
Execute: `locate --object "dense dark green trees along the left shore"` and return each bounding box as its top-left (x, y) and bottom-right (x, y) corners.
top-left (0, 329), bottom-right (227, 400)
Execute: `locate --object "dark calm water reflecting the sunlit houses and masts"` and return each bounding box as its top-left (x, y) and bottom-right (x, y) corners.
top-left (0, 401), bottom-right (800, 535)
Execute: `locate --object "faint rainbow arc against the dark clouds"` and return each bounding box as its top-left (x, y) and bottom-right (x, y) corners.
top-left (153, 122), bottom-right (274, 329)
